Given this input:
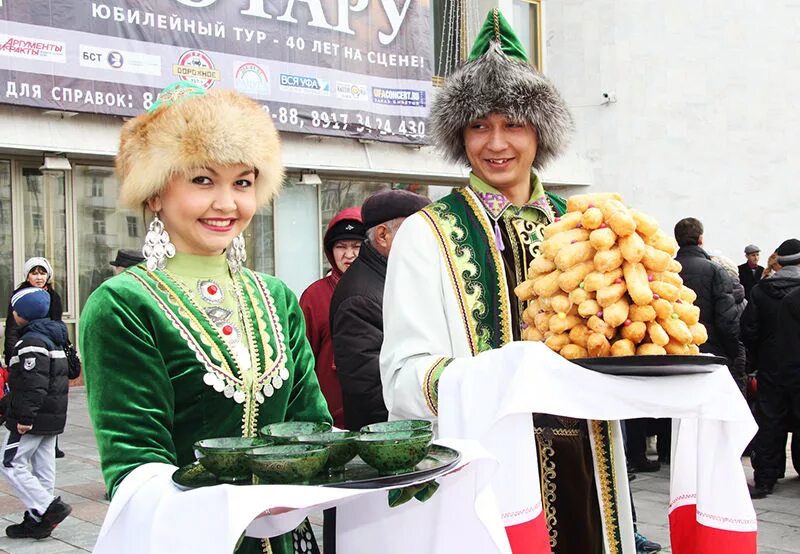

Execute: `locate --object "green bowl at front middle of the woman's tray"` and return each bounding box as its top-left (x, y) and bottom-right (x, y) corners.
top-left (247, 444), bottom-right (328, 485)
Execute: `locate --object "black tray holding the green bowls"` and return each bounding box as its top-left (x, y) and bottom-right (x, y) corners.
top-left (172, 444), bottom-right (461, 490)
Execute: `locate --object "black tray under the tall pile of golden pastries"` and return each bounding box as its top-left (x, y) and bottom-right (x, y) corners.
top-left (571, 355), bottom-right (727, 377)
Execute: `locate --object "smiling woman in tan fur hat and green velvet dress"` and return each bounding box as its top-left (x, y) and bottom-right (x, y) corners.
top-left (80, 83), bottom-right (331, 554)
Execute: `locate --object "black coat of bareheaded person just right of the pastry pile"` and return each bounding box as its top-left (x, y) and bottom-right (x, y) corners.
top-left (675, 246), bottom-right (740, 358)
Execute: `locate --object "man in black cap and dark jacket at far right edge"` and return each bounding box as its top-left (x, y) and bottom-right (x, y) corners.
top-left (742, 239), bottom-right (800, 498)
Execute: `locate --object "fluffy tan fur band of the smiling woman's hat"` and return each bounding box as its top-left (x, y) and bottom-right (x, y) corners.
top-left (116, 90), bottom-right (283, 209)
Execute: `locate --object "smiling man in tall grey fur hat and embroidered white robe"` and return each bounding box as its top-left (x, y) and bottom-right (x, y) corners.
top-left (381, 9), bottom-right (658, 554)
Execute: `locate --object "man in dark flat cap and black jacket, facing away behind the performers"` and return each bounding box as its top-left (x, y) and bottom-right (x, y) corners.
top-left (330, 190), bottom-right (430, 431)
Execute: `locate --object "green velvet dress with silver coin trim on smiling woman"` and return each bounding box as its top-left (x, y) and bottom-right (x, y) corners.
top-left (80, 254), bottom-right (332, 554)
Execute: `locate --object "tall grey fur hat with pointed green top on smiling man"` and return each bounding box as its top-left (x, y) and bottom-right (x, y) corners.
top-left (429, 8), bottom-right (573, 169)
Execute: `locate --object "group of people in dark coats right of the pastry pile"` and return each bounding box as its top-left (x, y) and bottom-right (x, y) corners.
top-left (627, 227), bottom-right (800, 499)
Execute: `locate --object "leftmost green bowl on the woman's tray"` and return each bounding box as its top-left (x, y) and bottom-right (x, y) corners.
top-left (194, 437), bottom-right (272, 483)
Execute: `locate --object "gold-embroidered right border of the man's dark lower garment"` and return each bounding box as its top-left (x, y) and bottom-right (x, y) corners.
top-left (589, 420), bottom-right (622, 554)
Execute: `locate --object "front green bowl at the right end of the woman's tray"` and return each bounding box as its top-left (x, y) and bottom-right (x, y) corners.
top-left (356, 431), bottom-right (433, 475)
